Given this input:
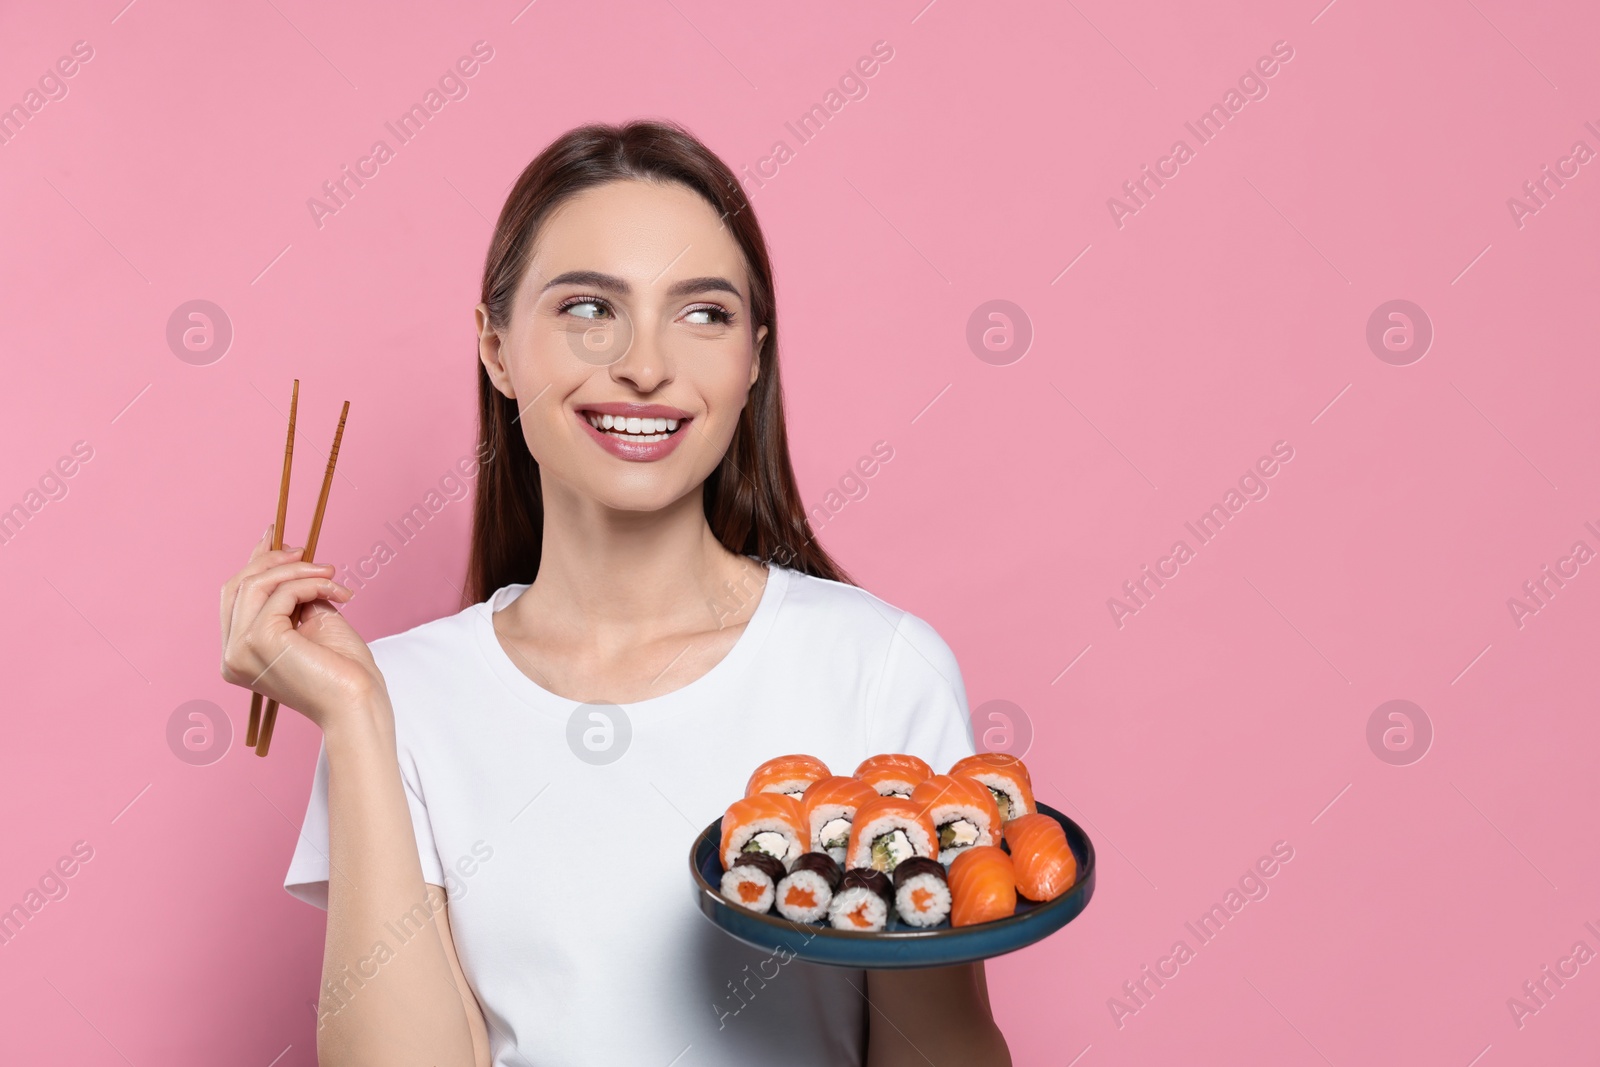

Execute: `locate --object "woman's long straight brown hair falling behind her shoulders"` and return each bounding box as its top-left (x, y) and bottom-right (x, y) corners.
top-left (466, 122), bottom-right (850, 603)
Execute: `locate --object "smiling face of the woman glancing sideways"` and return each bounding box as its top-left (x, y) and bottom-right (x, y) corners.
top-left (478, 181), bottom-right (766, 510)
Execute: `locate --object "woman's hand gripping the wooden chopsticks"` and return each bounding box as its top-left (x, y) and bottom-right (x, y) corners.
top-left (222, 526), bottom-right (387, 733)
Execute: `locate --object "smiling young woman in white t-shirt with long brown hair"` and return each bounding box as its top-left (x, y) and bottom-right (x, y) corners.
top-left (222, 122), bottom-right (1010, 1067)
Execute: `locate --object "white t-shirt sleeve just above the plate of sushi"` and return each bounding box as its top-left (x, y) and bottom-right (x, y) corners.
top-left (867, 604), bottom-right (974, 774)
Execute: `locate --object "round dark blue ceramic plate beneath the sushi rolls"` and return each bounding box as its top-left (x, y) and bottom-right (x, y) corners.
top-left (690, 805), bottom-right (1094, 971)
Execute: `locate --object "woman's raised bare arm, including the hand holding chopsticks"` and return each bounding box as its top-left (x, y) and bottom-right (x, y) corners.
top-left (222, 537), bottom-right (488, 1067)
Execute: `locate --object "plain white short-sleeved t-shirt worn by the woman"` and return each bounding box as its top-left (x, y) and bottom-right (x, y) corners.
top-left (285, 566), bottom-right (973, 1067)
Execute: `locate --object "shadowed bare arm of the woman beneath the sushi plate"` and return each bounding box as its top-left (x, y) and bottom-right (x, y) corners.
top-left (867, 963), bottom-right (1011, 1067)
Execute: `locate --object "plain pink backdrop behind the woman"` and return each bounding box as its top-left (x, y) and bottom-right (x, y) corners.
top-left (0, 0), bottom-right (1600, 1067)
